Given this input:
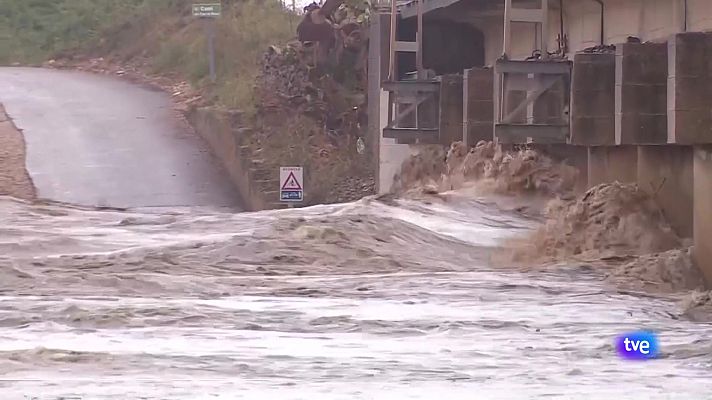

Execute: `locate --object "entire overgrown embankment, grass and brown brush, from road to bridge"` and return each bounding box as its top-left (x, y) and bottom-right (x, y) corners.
top-left (0, 0), bottom-right (374, 206)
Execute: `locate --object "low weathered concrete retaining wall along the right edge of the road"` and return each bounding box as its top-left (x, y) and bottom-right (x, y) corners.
top-left (188, 108), bottom-right (266, 211)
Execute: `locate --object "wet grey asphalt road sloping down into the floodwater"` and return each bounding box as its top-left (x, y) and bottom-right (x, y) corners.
top-left (0, 68), bottom-right (240, 209)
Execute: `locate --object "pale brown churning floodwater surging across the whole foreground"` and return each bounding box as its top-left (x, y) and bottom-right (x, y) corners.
top-left (0, 193), bottom-right (712, 400)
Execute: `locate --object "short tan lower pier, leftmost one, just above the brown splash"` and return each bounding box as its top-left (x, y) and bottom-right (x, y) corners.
top-left (588, 146), bottom-right (638, 187)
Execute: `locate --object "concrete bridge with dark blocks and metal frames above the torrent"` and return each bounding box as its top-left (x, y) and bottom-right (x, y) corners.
top-left (369, 0), bottom-right (712, 285)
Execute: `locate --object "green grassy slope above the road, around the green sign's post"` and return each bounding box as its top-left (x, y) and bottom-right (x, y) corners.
top-left (0, 0), bottom-right (298, 109)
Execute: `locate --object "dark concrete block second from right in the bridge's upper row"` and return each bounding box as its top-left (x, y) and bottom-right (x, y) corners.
top-left (615, 43), bottom-right (668, 144)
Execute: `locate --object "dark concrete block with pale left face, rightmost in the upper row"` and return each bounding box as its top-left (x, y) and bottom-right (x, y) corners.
top-left (668, 32), bottom-right (712, 144)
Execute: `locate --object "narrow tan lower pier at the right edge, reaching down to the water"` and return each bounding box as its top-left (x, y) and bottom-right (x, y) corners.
top-left (693, 145), bottom-right (712, 287)
